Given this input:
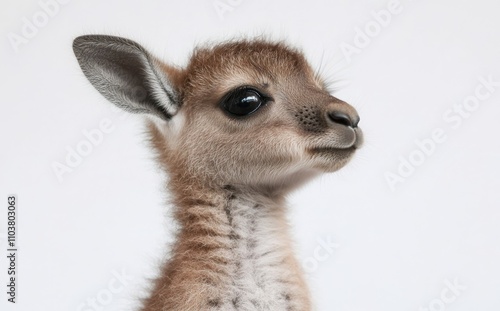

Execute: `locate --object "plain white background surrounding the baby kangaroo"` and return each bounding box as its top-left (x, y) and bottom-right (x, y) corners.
top-left (0, 0), bottom-right (500, 311)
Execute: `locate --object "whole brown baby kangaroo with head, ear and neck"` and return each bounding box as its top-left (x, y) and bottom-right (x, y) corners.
top-left (73, 35), bottom-right (363, 311)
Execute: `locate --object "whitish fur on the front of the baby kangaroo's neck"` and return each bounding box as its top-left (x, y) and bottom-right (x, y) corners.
top-left (219, 198), bottom-right (304, 311)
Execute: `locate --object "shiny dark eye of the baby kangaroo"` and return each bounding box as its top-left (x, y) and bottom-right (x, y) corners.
top-left (222, 87), bottom-right (267, 116)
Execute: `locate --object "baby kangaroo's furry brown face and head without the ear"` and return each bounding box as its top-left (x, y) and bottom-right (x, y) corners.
top-left (141, 41), bottom-right (362, 189)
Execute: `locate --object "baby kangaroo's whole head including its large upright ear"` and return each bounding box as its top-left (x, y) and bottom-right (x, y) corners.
top-left (73, 35), bottom-right (363, 194)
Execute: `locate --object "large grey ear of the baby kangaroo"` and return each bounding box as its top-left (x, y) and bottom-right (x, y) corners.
top-left (73, 35), bottom-right (180, 120)
